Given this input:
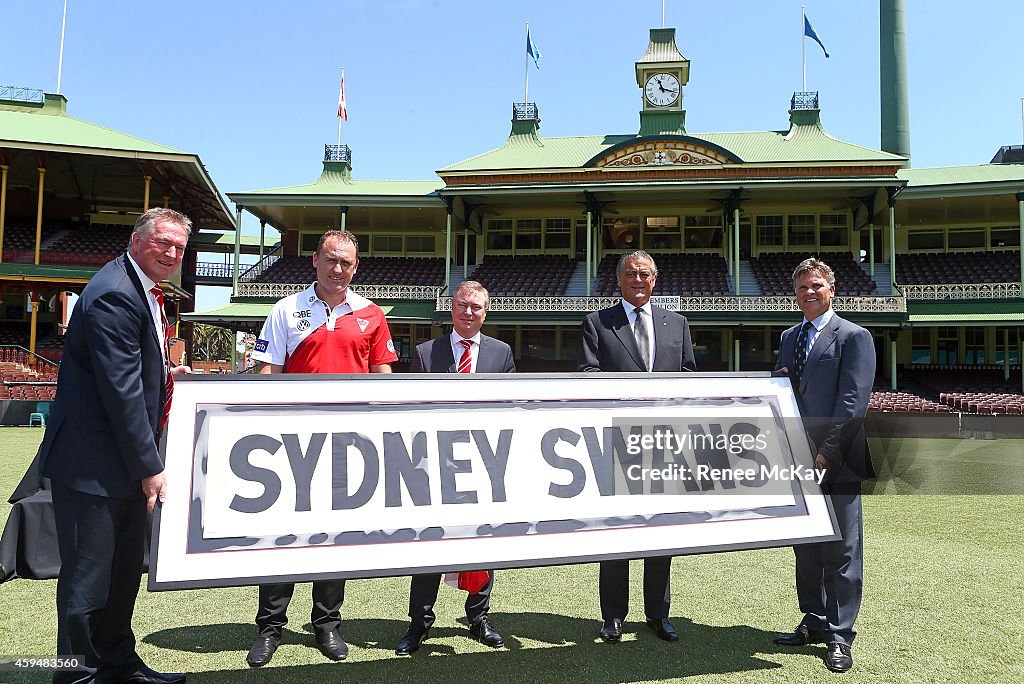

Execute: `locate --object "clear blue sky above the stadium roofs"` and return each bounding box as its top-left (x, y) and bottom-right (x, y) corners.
top-left (0, 0), bottom-right (1024, 309)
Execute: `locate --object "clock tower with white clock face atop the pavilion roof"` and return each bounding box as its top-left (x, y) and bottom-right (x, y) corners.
top-left (636, 29), bottom-right (690, 136)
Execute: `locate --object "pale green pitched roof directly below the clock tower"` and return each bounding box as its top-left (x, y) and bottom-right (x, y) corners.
top-left (438, 124), bottom-right (904, 174)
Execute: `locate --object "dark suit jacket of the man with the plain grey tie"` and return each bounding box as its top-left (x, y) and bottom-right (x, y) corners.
top-left (577, 303), bottom-right (696, 373)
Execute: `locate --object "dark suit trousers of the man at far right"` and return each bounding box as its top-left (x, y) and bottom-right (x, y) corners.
top-left (794, 482), bottom-right (864, 644)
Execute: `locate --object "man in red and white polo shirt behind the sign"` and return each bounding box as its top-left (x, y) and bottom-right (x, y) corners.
top-left (246, 230), bottom-right (398, 668)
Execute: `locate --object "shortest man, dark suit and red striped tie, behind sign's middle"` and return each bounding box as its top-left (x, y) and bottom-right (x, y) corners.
top-left (395, 281), bottom-right (515, 655)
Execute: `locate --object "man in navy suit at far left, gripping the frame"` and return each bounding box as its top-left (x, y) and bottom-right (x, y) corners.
top-left (40, 209), bottom-right (191, 684)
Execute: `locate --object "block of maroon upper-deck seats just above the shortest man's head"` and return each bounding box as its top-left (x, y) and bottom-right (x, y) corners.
top-left (470, 254), bottom-right (575, 297)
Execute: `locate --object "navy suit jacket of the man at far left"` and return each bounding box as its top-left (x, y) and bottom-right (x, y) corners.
top-left (40, 254), bottom-right (165, 499)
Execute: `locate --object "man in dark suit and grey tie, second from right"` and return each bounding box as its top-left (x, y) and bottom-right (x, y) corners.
top-left (577, 250), bottom-right (696, 643)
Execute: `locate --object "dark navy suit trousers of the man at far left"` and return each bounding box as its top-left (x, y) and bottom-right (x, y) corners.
top-left (52, 481), bottom-right (146, 683)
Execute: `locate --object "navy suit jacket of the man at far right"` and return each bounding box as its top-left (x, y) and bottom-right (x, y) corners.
top-left (775, 315), bottom-right (874, 482)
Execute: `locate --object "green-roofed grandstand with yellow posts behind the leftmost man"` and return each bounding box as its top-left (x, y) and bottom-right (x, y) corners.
top-left (0, 87), bottom-right (245, 411)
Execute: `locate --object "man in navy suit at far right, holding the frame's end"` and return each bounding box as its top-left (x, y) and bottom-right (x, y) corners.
top-left (774, 259), bottom-right (874, 672)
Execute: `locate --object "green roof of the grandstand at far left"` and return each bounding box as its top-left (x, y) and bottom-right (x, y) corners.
top-left (0, 94), bottom-right (185, 155)
